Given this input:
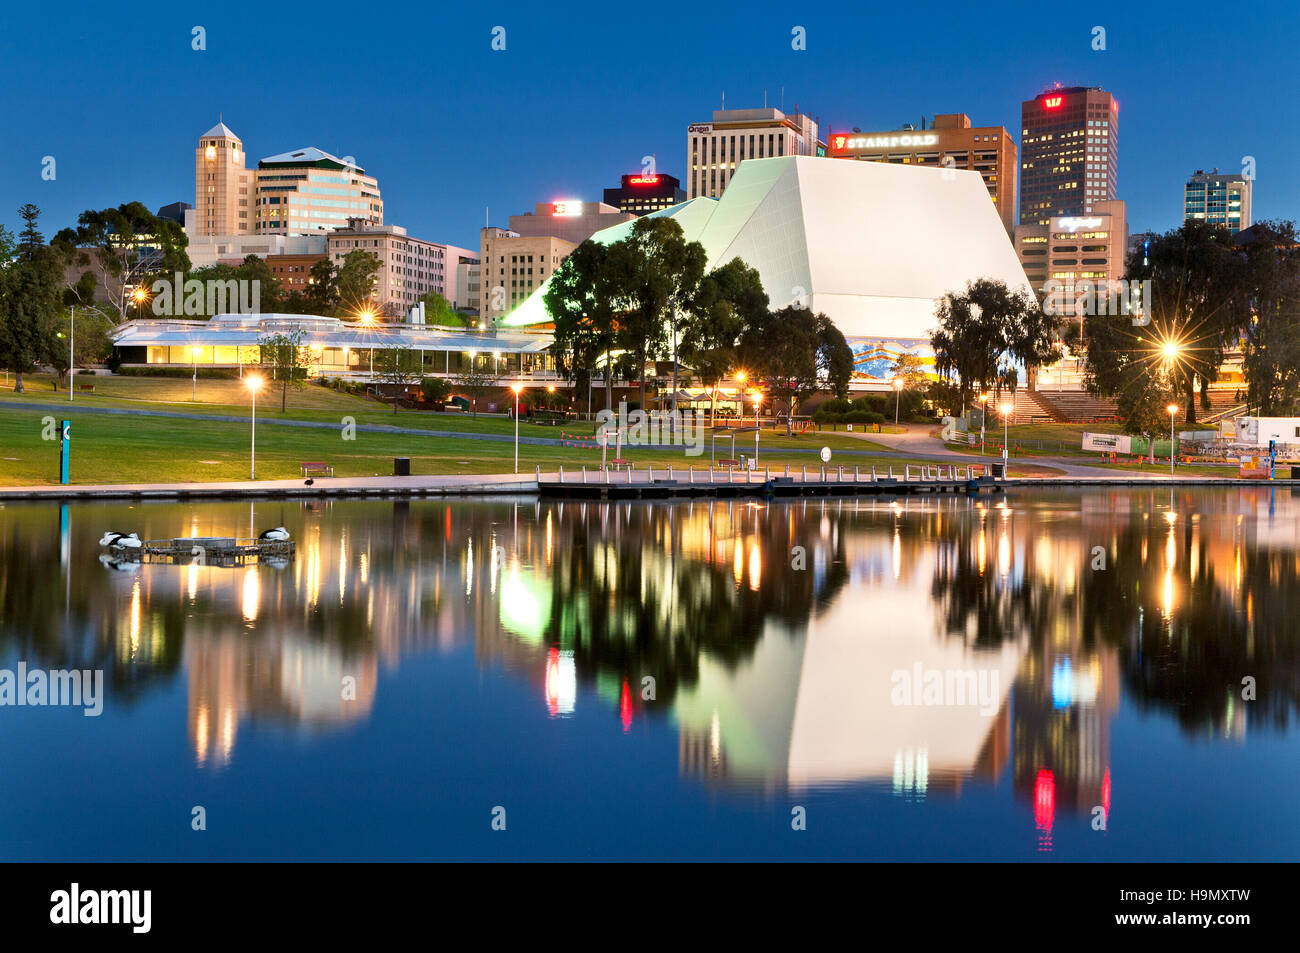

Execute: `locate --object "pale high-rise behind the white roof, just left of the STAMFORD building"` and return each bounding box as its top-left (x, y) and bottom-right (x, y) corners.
top-left (686, 107), bottom-right (826, 199)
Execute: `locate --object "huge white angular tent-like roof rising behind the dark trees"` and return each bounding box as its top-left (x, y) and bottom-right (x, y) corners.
top-left (504, 156), bottom-right (1030, 341)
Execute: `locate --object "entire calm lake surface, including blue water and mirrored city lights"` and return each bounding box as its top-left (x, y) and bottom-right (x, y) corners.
top-left (0, 488), bottom-right (1300, 861)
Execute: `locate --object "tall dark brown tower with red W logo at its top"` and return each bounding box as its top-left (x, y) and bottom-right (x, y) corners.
top-left (1021, 86), bottom-right (1119, 225)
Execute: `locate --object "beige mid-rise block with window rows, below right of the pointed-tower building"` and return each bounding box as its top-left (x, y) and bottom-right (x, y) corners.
top-left (326, 218), bottom-right (473, 317)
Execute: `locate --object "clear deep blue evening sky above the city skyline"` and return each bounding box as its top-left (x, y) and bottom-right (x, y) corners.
top-left (0, 0), bottom-right (1300, 248)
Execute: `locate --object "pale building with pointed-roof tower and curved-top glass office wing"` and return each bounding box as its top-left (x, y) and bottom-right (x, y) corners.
top-left (194, 122), bottom-right (384, 237)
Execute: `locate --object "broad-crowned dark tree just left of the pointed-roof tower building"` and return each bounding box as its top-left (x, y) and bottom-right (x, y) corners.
top-left (51, 202), bottom-right (190, 321)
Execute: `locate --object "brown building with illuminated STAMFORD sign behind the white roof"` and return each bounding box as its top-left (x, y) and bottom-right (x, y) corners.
top-left (826, 113), bottom-right (1019, 234)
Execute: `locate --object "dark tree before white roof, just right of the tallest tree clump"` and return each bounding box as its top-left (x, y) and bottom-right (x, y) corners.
top-left (675, 259), bottom-right (768, 424)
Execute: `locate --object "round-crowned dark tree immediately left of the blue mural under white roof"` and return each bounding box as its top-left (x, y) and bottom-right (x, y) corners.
top-left (740, 304), bottom-right (853, 434)
